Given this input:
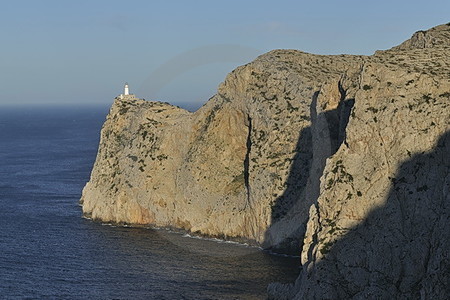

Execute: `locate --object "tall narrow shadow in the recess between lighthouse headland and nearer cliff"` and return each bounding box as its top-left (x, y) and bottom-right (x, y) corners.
top-left (263, 90), bottom-right (355, 255)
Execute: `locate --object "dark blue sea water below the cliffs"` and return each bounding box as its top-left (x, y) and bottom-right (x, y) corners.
top-left (0, 107), bottom-right (298, 299)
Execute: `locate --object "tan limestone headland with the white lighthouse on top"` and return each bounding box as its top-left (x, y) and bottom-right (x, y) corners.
top-left (81, 50), bottom-right (364, 253)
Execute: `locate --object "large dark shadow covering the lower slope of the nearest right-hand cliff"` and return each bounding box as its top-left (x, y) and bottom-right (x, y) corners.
top-left (284, 131), bottom-right (450, 299)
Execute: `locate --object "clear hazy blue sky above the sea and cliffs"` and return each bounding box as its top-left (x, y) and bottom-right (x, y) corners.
top-left (0, 0), bottom-right (450, 106)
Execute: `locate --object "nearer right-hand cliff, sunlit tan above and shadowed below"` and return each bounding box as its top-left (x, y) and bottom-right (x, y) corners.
top-left (269, 25), bottom-right (450, 299)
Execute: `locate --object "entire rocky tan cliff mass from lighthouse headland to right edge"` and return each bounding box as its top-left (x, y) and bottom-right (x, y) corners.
top-left (81, 25), bottom-right (450, 299)
